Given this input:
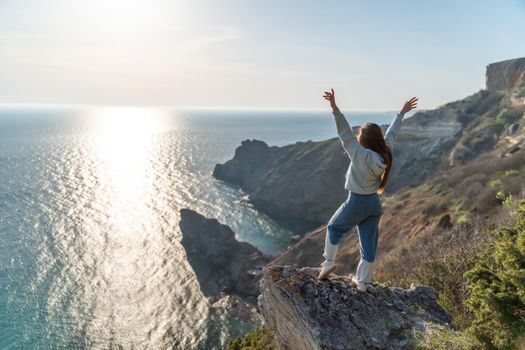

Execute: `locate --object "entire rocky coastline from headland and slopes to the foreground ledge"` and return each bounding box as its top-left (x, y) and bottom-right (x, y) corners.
top-left (186, 58), bottom-right (525, 349)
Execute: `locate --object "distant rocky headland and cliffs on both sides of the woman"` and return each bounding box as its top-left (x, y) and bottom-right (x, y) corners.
top-left (213, 58), bottom-right (525, 233)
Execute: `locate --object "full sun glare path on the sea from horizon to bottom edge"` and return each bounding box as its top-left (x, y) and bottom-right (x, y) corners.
top-left (77, 108), bottom-right (196, 345)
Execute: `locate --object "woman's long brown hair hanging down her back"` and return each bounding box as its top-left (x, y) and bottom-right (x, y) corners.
top-left (357, 123), bottom-right (393, 193)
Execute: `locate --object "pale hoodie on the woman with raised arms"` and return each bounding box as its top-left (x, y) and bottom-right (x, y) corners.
top-left (333, 110), bottom-right (403, 194)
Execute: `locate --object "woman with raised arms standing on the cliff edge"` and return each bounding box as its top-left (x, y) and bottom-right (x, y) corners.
top-left (318, 89), bottom-right (417, 292)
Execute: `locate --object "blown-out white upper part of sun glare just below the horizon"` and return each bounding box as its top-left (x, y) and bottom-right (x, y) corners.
top-left (89, 107), bottom-right (168, 236)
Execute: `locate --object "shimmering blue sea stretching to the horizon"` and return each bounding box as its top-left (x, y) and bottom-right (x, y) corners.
top-left (0, 105), bottom-right (394, 349)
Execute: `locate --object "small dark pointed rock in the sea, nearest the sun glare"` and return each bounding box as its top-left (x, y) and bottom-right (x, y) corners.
top-left (179, 209), bottom-right (272, 303)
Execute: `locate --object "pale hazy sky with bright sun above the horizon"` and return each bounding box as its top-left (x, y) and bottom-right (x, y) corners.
top-left (0, 0), bottom-right (525, 111)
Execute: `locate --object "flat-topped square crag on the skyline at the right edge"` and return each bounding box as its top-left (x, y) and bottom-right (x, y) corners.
top-left (485, 57), bottom-right (525, 91)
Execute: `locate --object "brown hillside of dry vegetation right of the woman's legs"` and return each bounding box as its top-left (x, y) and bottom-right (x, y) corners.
top-left (376, 151), bottom-right (525, 340)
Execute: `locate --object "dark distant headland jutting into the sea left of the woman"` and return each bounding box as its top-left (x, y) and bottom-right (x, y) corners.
top-left (213, 139), bottom-right (350, 232)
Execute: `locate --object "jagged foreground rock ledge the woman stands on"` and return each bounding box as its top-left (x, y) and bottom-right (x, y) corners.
top-left (258, 265), bottom-right (451, 350)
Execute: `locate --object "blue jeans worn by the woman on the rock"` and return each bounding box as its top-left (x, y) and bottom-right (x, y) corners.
top-left (327, 192), bottom-right (383, 263)
